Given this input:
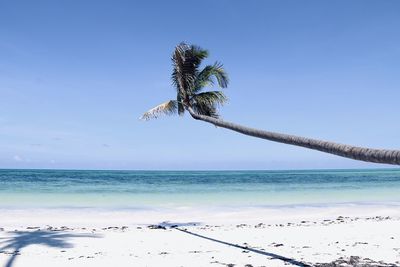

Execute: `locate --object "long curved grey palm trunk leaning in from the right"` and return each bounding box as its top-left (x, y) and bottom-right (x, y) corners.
top-left (187, 107), bottom-right (400, 165)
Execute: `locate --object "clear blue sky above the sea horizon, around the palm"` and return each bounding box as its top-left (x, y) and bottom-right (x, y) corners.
top-left (0, 0), bottom-right (400, 169)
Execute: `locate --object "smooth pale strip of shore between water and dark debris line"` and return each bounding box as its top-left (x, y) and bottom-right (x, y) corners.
top-left (0, 202), bottom-right (400, 228)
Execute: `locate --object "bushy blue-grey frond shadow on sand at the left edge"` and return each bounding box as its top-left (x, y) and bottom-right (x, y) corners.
top-left (0, 230), bottom-right (99, 267)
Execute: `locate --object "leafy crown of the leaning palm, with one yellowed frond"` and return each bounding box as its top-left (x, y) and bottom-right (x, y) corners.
top-left (141, 43), bottom-right (228, 120)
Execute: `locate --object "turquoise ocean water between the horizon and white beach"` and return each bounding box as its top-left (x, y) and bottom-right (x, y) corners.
top-left (0, 169), bottom-right (400, 209)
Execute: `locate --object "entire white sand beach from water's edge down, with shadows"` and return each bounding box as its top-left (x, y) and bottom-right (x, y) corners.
top-left (0, 206), bottom-right (400, 267)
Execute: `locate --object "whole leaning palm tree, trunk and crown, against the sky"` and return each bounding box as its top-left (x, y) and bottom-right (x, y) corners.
top-left (141, 43), bottom-right (400, 165)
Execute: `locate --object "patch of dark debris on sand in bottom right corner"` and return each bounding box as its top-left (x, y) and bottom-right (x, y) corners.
top-left (313, 256), bottom-right (400, 267)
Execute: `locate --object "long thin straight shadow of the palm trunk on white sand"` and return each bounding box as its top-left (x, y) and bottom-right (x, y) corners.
top-left (172, 227), bottom-right (311, 267)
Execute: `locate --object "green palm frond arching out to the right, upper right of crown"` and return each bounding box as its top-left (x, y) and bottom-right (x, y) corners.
top-left (193, 62), bottom-right (229, 92)
